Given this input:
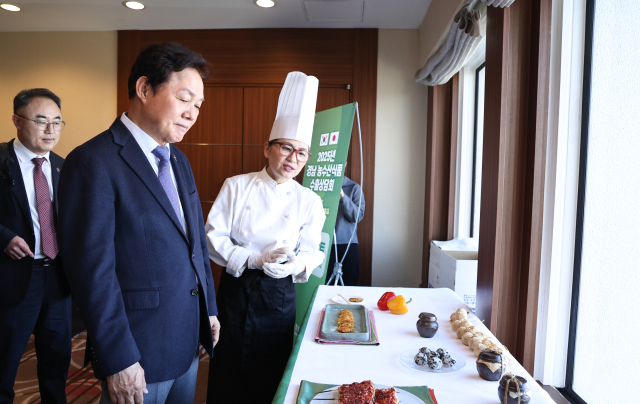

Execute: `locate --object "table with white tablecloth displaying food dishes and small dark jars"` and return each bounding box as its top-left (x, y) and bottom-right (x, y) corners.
top-left (274, 286), bottom-right (554, 404)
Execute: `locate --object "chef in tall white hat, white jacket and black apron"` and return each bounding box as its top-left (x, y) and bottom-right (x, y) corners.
top-left (205, 72), bottom-right (325, 404)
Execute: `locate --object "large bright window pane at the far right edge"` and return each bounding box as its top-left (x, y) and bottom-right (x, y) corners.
top-left (562, 0), bottom-right (640, 404)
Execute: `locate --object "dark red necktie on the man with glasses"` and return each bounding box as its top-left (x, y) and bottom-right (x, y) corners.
top-left (31, 157), bottom-right (58, 259)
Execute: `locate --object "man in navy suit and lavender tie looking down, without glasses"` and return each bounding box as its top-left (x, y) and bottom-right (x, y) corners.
top-left (59, 43), bottom-right (220, 403)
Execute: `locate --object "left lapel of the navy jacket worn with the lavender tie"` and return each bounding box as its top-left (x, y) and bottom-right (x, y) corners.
top-left (110, 118), bottom-right (188, 241)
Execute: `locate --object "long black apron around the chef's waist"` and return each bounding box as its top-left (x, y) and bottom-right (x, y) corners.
top-left (207, 269), bottom-right (296, 404)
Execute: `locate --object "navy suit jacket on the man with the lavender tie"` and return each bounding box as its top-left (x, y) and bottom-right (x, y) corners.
top-left (58, 118), bottom-right (218, 383)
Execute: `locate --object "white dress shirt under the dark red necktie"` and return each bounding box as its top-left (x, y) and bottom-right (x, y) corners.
top-left (13, 138), bottom-right (53, 259)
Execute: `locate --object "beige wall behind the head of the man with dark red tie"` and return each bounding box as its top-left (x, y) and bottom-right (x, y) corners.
top-left (0, 31), bottom-right (118, 157)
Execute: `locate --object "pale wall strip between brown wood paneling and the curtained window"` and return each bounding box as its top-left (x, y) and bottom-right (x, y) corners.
top-left (372, 29), bottom-right (427, 287)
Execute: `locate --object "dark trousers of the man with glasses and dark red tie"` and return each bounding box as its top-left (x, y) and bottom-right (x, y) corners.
top-left (0, 266), bottom-right (71, 404)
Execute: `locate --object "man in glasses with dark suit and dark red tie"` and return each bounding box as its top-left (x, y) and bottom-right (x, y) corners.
top-left (0, 88), bottom-right (71, 404)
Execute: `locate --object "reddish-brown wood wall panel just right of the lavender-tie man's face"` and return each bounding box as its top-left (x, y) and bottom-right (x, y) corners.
top-left (188, 86), bottom-right (244, 145)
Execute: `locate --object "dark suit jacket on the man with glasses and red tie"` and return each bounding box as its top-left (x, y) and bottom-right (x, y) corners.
top-left (0, 140), bottom-right (68, 308)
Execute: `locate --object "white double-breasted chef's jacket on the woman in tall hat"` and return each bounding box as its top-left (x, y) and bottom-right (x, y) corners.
top-left (205, 169), bottom-right (325, 283)
